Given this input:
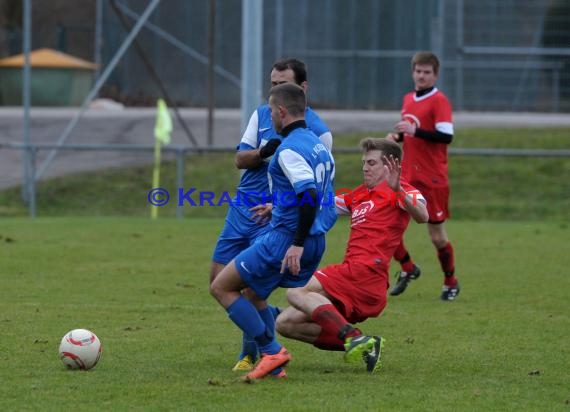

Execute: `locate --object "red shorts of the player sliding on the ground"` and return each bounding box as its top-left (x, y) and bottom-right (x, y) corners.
top-left (313, 263), bottom-right (388, 323)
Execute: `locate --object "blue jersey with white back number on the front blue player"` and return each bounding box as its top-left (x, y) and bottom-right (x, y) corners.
top-left (269, 127), bottom-right (336, 236)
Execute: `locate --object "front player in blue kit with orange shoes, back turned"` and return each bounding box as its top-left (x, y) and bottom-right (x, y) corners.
top-left (210, 83), bottom-right (335, 379)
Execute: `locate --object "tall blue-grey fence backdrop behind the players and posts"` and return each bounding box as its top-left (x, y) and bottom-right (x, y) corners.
top-left (95, 0), bottom-right (570, 112)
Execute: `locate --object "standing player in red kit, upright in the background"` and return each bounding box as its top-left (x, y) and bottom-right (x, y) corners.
top-left (388, 51), bottom-right (460, 301)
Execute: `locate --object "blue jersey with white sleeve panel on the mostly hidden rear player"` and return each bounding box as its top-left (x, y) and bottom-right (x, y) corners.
top-left (234, 104), bottom-right (332, 207)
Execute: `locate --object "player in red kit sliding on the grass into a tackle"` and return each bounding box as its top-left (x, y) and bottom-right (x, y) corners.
top-left (277, 138), bottom-right (428, 372)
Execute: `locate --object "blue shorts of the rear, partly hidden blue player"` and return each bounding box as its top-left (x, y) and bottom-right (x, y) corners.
top-left (212, 206), bottom-right (270, 265)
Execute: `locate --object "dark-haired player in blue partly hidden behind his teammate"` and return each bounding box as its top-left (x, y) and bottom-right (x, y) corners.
top-left (210, 58), bottom-right (332, 371)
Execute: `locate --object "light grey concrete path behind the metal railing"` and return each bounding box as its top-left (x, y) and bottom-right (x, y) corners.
top-left (0, 107), bottom-right (570, 189)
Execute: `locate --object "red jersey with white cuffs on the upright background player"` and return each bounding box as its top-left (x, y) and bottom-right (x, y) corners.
top-left (402, 87), bottom-right (453, 187)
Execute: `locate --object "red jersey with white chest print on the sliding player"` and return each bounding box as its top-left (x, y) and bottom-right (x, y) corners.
top-left (338, 181), bottom-right (424, 273)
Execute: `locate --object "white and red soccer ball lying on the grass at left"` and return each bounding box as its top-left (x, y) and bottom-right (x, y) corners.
top-left (59, 329), bottom-right (101, 370)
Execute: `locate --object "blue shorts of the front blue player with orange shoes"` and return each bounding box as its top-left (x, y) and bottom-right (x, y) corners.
top-left (235, 230), bottom-right (325, 299)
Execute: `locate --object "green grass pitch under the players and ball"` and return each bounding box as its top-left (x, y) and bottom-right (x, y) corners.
top-left (0, 218), bottom-right (570, 411)
